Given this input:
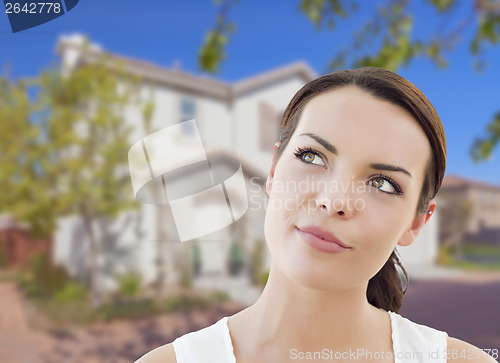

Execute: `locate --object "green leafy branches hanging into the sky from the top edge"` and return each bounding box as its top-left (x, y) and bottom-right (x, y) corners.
top-left (198, 0), bottom-right (500, 161)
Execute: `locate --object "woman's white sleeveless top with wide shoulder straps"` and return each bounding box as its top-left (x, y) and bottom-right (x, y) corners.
top-left (173, 311), bottom-right (448, 363)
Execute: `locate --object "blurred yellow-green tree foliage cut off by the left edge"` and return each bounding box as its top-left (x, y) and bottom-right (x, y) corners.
top-left (0, 77), bottom-right (55, 236)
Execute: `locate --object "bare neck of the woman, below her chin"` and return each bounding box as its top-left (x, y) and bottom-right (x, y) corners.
top-left (234, 266), bottom-right (388, 352)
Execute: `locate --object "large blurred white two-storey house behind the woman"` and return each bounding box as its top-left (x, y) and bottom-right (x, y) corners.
top-left (49, 36), bottom-right (437, 300)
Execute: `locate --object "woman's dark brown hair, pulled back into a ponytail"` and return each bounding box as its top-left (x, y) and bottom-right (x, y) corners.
top-left (274, 67), bottom-right (446, 312)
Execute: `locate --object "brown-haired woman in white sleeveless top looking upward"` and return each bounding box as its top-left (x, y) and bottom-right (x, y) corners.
top-left (139, 68), bottom-right (494, 363)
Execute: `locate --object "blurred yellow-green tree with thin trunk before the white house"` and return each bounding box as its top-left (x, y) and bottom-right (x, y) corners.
top-left (40, 58), bottom-right (143, 305)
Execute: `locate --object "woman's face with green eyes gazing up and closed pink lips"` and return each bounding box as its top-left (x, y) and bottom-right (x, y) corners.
top-left (265, 86), bottom-right (435, 290)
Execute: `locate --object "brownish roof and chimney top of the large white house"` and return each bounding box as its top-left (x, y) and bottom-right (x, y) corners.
top-left (56, 34), bottom-right (317, 101)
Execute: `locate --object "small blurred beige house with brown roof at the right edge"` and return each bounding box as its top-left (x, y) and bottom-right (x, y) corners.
top-left (438, 175), bottom-right (500, 246)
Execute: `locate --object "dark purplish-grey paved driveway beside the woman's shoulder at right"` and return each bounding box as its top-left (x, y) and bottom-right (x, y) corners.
top-left (400, 272), bottom-right (500, 350)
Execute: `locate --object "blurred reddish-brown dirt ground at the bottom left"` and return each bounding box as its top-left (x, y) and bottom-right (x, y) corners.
top-left (0, 282), bottom-right (244, 363)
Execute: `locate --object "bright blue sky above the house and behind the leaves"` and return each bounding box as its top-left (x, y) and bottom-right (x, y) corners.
top-left (0, 0), bottom-right (500, 185)
